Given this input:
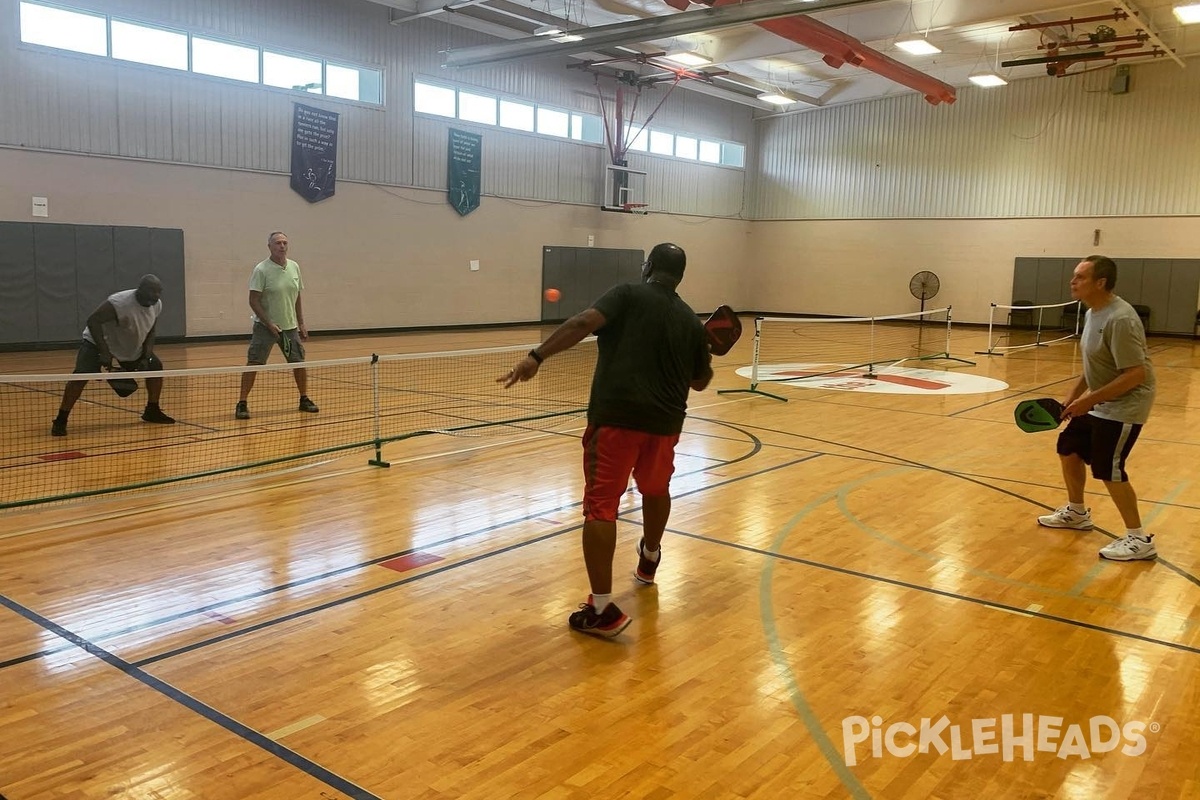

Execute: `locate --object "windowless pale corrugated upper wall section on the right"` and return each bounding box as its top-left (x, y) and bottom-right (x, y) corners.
top-left (751, 61), bottom-right (1200, 219)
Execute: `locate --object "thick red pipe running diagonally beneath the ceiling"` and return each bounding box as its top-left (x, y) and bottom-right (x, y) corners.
top-left (666, 0), bottom-right (958, 106)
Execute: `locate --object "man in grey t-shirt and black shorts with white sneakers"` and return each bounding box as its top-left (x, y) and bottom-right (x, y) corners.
top-left (1038, 255), bottom-right (1158, 561)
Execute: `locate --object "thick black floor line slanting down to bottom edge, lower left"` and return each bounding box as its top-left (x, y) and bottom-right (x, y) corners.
top-left (0, 595), bottom-right (382, 800)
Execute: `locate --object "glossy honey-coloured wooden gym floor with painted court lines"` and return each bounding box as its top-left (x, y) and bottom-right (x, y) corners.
top-left (0, 329), bottom-right (1200, 800)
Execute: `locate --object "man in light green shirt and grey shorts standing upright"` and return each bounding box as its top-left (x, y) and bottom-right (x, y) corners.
top-left (234, 230), bottom-right (320, 420)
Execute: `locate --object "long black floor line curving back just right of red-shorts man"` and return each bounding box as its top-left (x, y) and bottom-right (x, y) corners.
top-left (0, 417), bottom-right (763, 670)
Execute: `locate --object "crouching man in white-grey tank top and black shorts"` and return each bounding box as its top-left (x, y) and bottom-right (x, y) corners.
top-left (50, 275), bottom-right (175, 437)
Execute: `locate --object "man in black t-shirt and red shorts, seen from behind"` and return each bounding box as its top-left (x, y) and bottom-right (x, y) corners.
top-left (497, 243), bottom-right (713, 637)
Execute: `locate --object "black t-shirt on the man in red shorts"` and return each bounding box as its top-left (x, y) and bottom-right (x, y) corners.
top-left (588, 283), bottom-right (712, 435)
